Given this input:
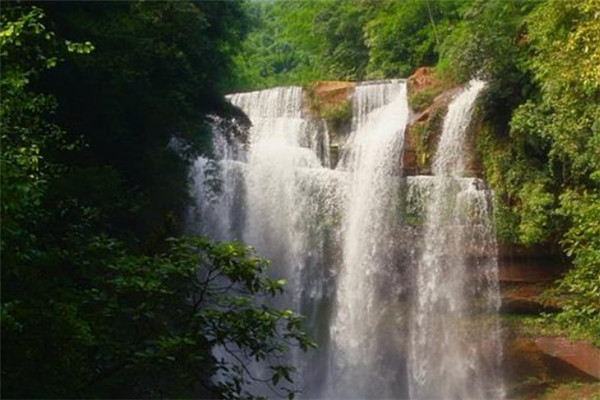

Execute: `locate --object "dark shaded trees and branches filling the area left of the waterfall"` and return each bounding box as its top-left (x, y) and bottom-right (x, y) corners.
top-left (0, 2), bottom-right (313, 398)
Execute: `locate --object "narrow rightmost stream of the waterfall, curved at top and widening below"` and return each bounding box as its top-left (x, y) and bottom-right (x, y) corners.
top-left (408, 80), bottom-right (503, 400)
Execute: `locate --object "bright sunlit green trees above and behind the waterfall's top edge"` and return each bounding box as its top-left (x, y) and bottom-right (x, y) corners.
top-left (235, 0), bottom-right (461, 88)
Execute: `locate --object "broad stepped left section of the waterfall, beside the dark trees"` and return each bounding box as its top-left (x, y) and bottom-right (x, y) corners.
top-left (192, 87), bottom-right (345, 395)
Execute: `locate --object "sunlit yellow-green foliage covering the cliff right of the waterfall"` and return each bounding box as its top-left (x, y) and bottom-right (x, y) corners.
top-left (468, 0), bottom-right (600, 344)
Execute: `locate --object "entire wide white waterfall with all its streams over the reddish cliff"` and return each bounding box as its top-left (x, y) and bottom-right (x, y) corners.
top-left (189, 80), bottom-right (502, 400)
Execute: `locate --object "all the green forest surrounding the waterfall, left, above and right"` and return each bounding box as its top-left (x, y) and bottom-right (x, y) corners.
top-left (0, 0), bottom-right (600, 398)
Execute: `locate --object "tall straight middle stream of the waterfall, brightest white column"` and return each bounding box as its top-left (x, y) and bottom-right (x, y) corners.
top-left (327, 81), bottom-right (408, 399)
